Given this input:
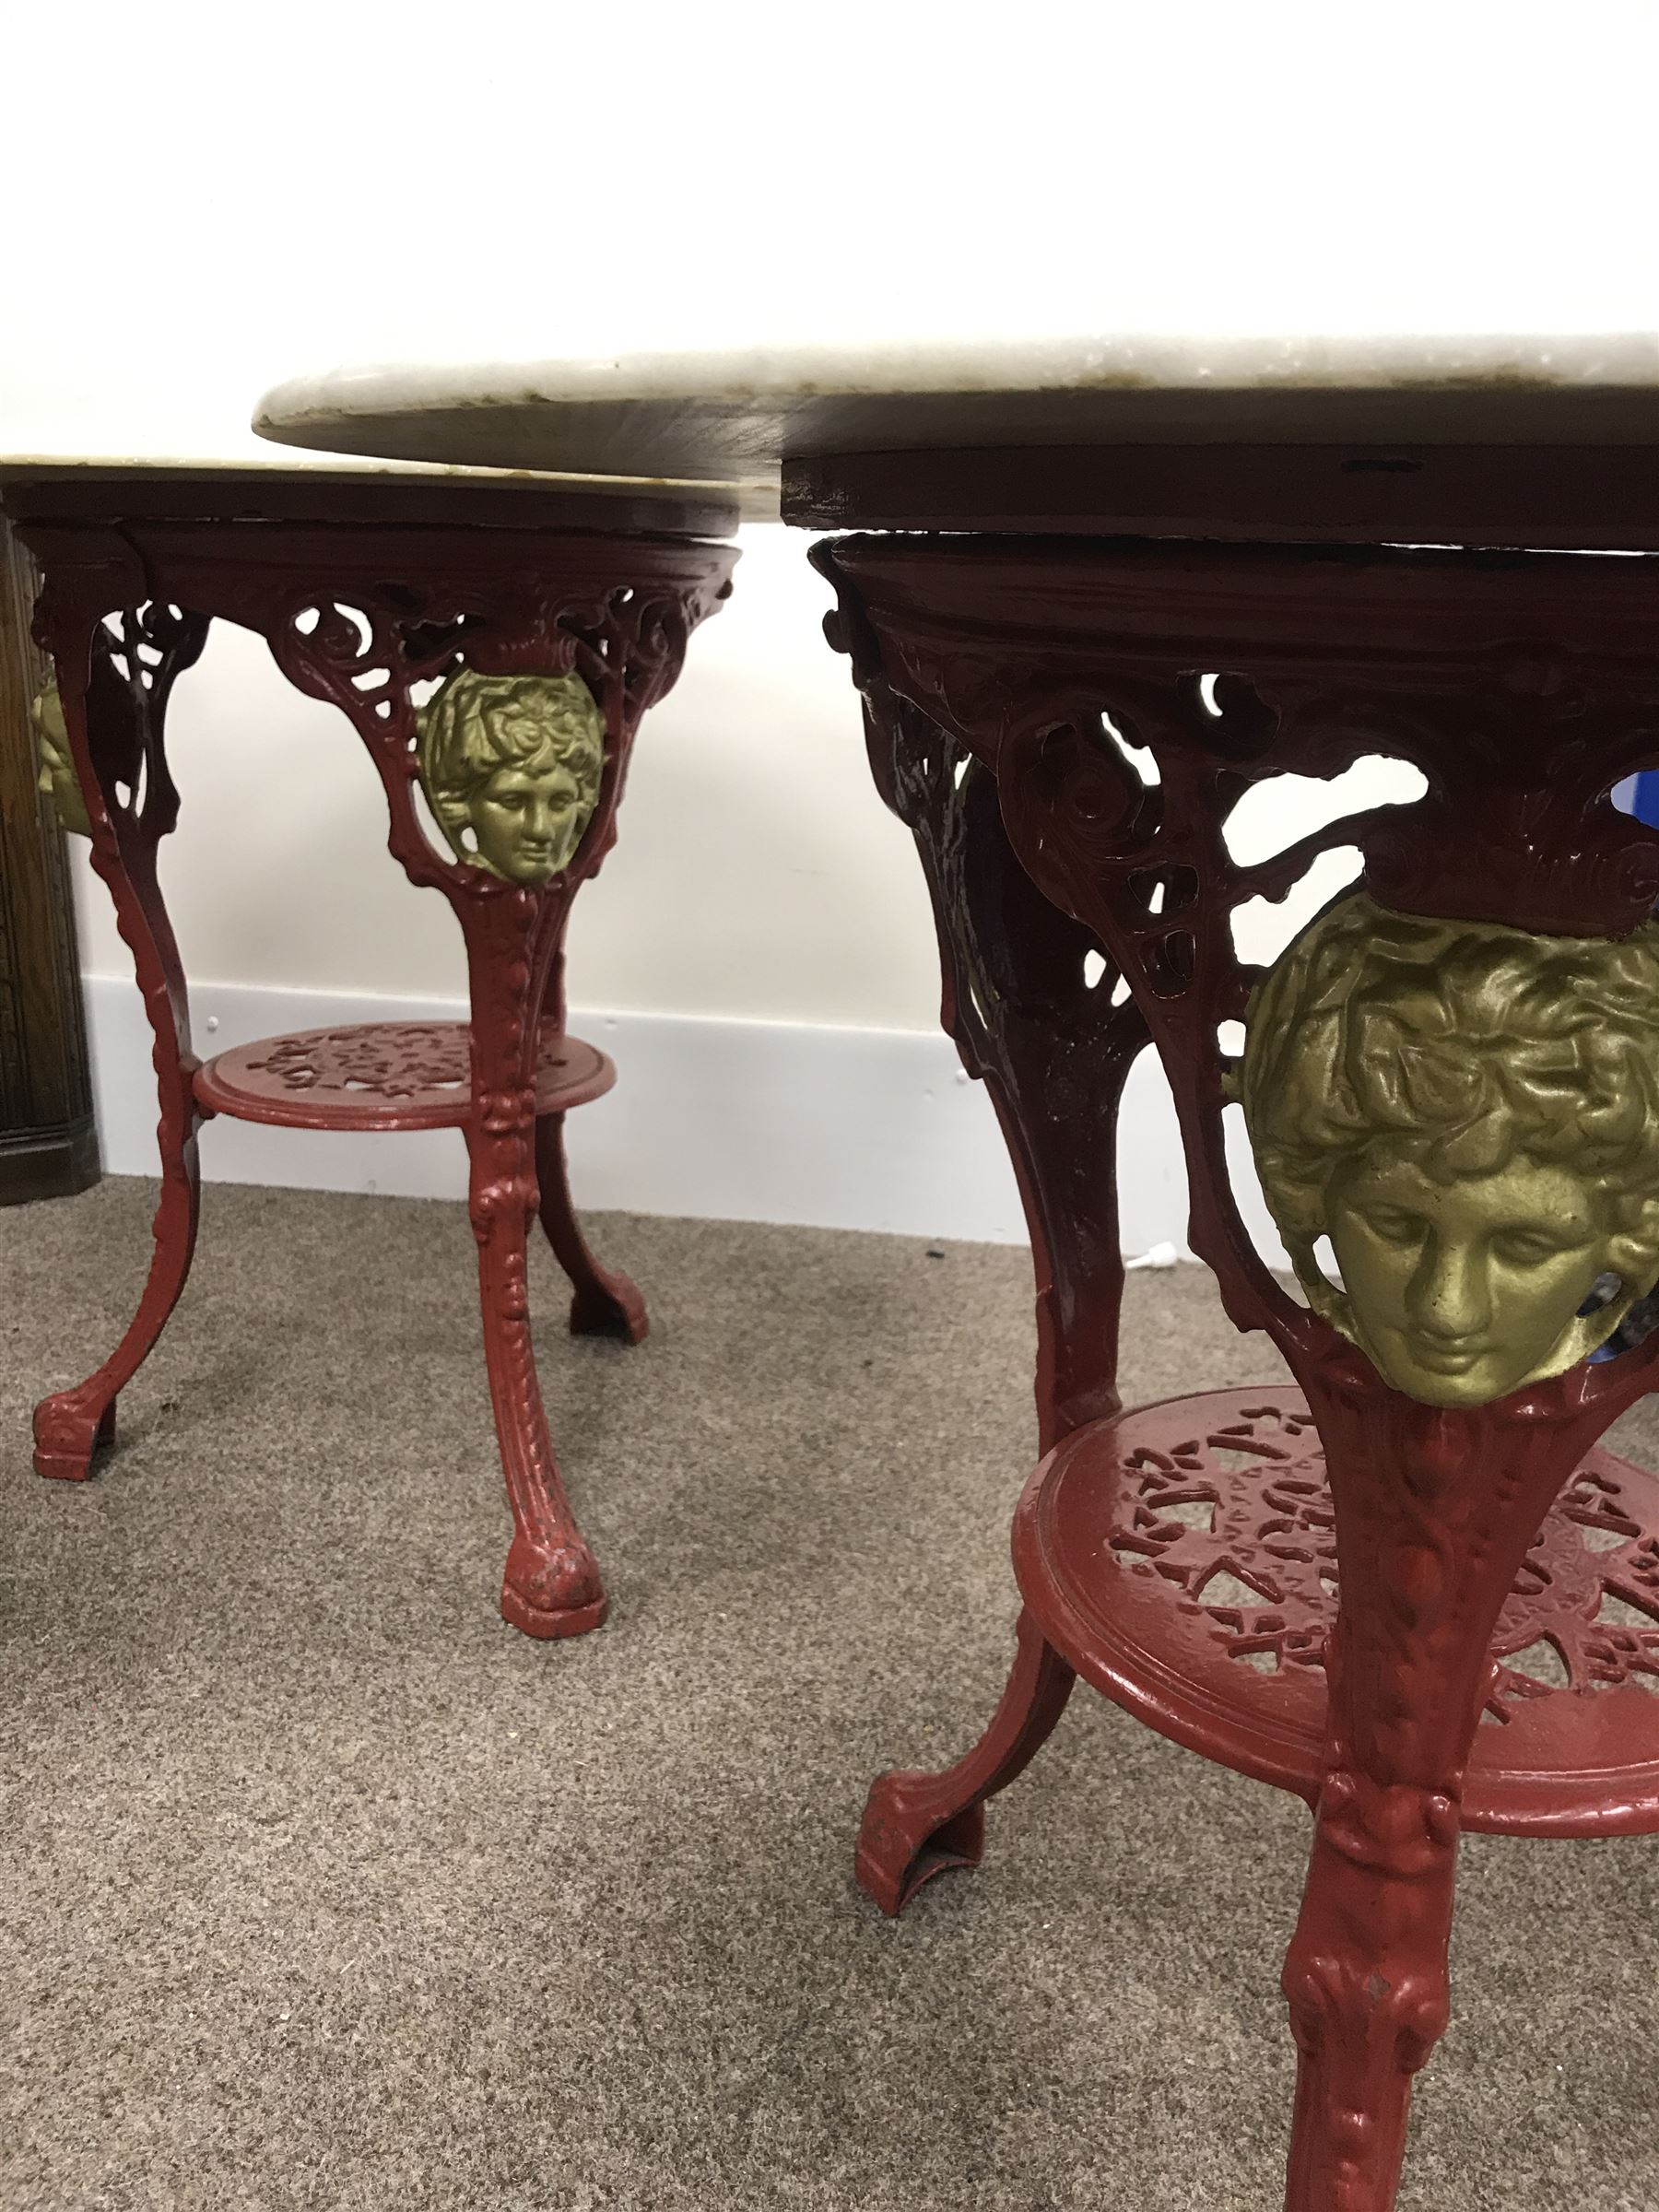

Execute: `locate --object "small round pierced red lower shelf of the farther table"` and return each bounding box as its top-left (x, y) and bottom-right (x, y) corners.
top-left (194, 1022), bottom-right (618, 1130)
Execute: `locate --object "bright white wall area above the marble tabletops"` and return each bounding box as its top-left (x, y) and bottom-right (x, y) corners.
top-left (0, 0), bottom-right (1659, 453)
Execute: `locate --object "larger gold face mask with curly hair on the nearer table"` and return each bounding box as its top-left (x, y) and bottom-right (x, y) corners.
top-left (1239, 894), bottom-right (1659, 1406)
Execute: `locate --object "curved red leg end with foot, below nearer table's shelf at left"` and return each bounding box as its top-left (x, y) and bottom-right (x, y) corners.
top-left (856, 1613), bottom-right (1077, 1915)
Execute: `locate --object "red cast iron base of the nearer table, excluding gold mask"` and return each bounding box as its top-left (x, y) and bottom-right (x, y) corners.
top-left (814, 517), bottom-right (1659, 2212)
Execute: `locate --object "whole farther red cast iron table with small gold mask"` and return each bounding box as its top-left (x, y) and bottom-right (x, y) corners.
top-left (0, 460), bottom-right (739, 1637)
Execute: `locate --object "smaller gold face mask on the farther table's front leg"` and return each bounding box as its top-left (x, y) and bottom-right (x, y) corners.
top-left (416, 668), bottom-right (604, 887)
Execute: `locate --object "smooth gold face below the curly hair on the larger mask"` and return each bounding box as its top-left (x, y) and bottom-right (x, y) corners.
top-left (1329, 1152), bottom-right (1610, 1406)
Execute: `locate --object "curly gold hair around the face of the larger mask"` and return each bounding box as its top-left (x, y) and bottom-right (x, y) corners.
top-left (1239, 894), bottom-right (1659, 1365)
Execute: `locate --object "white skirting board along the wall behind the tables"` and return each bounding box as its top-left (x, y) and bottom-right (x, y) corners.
top-left (87, 975), bottom-right (1278, 1263)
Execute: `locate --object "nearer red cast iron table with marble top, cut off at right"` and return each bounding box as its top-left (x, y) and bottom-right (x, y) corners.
top-left (259, 336), bottom-right (1659, 2212)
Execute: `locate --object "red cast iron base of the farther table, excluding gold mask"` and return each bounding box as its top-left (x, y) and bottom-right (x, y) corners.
top-left (9, 493), bottom-right (736, 1637)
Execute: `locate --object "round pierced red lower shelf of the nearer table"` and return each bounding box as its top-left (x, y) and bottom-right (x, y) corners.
top-left (1013, 1389), bottom-right (1659, 1836)
